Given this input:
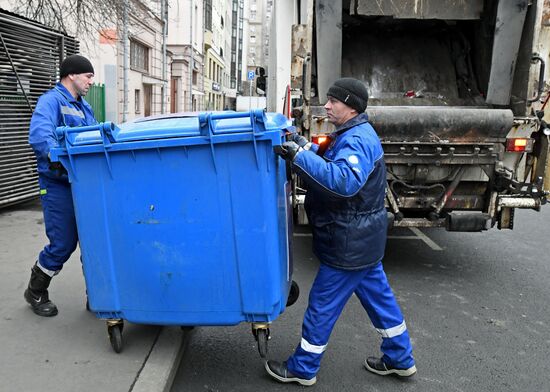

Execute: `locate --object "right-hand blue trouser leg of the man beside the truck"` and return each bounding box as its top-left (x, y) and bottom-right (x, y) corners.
top-left (355, 263), bottom-right (414, 369)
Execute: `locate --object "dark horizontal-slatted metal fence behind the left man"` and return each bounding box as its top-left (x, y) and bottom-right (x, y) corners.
top-left (0, 9), bottom-right (78, 208)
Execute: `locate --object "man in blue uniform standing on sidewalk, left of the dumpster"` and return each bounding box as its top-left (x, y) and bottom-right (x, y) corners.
top-left (24, 55), bottom-right (97, 317)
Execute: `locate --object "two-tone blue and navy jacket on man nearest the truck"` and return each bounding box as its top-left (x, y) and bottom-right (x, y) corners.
top-left (293, 113), bottom-right (388, 270)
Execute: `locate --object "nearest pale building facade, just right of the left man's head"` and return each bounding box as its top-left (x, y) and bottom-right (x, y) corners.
top-left (0, 0), bottom-right (170, 123)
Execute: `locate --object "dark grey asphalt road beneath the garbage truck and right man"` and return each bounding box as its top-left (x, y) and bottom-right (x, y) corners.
top-left (172, 206), bottom-right (550, 392)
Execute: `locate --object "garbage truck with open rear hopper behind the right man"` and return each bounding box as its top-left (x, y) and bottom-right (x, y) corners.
top-left (276, 0), bottom-right (550, 231)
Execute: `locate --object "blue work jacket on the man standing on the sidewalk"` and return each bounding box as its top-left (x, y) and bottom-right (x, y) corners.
top-left (29, 83), bottom-right (97, 181)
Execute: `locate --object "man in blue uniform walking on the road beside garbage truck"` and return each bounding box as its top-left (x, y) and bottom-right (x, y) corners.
top-left (265, 78), bottom-right (416, 386)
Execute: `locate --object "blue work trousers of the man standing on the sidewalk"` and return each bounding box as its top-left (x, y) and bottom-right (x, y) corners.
top-left (38, 175), bottom-right (78, 272)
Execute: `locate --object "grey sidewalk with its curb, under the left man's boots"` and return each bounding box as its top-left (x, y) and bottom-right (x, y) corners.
top-left (0, 201), bottom-right (185, 392)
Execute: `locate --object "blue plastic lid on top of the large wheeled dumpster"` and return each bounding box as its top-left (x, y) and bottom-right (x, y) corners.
top-left (62, 111), bottom-right (294, 146)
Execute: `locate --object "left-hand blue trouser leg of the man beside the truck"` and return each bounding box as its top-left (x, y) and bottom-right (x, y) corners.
top-left (287, 264), bottom-right (365, 379)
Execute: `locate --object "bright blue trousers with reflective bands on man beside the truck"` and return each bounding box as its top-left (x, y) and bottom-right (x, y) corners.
top-left (287, 262), bottom-right (414, 379)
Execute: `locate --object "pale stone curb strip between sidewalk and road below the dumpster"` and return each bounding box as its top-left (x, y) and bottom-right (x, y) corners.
top-left (129, 327), bottom-right (190, 392)
